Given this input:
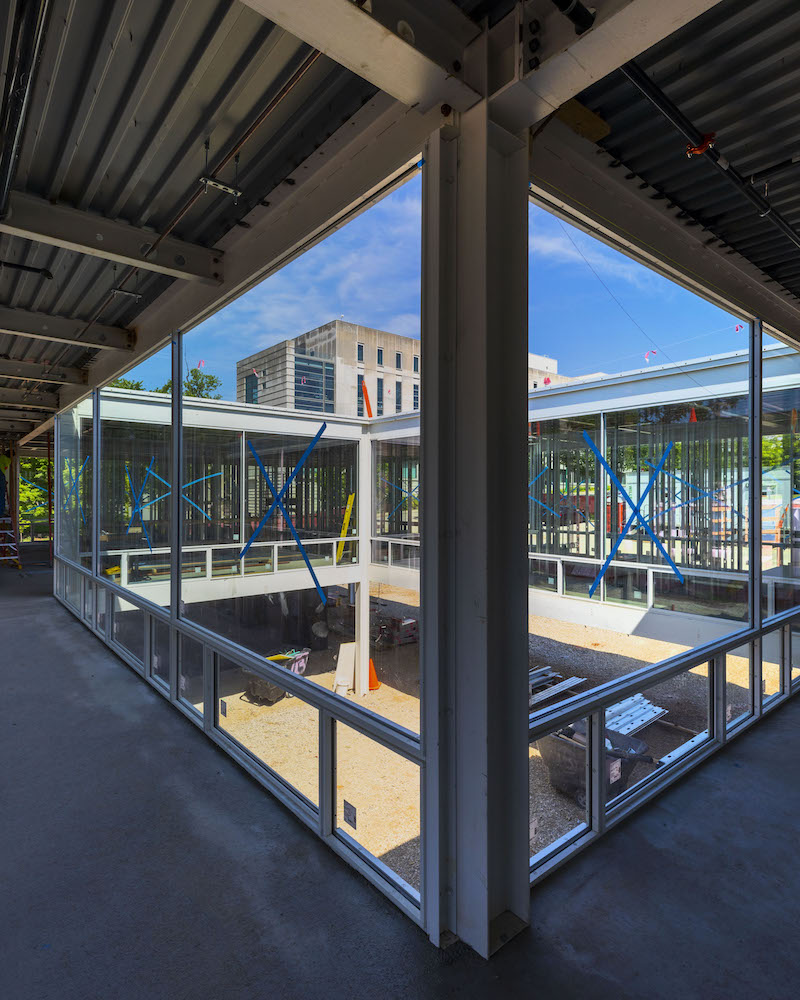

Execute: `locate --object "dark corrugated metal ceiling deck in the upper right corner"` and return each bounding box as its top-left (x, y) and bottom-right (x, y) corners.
top-left (579, 0), bottom-right (800, 306)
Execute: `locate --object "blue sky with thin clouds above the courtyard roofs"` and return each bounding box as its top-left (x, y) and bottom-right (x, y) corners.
top-left (120, 175), bottom-right (747, 399)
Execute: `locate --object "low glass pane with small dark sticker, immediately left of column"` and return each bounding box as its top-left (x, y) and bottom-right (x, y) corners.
top-left (336, 722), bottom-right (420, 893)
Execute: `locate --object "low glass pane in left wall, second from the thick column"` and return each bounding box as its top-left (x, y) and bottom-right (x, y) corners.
top-left (217, 656), bottom-right (319, 805)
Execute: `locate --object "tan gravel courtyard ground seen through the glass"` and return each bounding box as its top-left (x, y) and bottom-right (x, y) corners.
top-left (208, 600), bottom-right (777, 887)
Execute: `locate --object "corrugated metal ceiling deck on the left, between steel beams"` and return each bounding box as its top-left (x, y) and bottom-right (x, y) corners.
top-left (0, 0), bottom-right (375, 434)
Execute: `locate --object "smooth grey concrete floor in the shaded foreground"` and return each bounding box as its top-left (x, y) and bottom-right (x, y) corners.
top-left (0, 569), bottom-right (800, 1000)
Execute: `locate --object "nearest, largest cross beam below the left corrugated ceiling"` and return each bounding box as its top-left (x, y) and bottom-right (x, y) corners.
top-left (0, 191), bottom-right (222, 285)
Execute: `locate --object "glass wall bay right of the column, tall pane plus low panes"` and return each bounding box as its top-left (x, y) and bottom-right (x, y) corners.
top-left (527, 199), bottom-right (756, 859)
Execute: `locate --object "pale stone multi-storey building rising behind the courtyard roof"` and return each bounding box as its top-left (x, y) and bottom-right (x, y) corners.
top-left (236, 319), bottom-right (421, 417)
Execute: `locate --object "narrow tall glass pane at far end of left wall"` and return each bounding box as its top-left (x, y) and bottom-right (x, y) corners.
top-left (57, 397), bottom-right (93, 569)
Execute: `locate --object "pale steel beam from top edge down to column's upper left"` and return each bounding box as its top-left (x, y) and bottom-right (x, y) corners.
top-left (244, 0), bottom-right (481, 114)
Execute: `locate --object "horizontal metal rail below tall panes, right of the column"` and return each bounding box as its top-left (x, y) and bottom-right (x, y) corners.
top-left (528, 608), bottom-right (800, 740)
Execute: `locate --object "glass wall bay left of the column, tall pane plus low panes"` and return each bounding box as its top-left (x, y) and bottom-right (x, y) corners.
top-left (178, 168), bottom-right (421, 901)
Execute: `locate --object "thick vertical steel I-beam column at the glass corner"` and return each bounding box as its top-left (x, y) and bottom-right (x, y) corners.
top-left (421, 84), bottom-right (530, 957)
